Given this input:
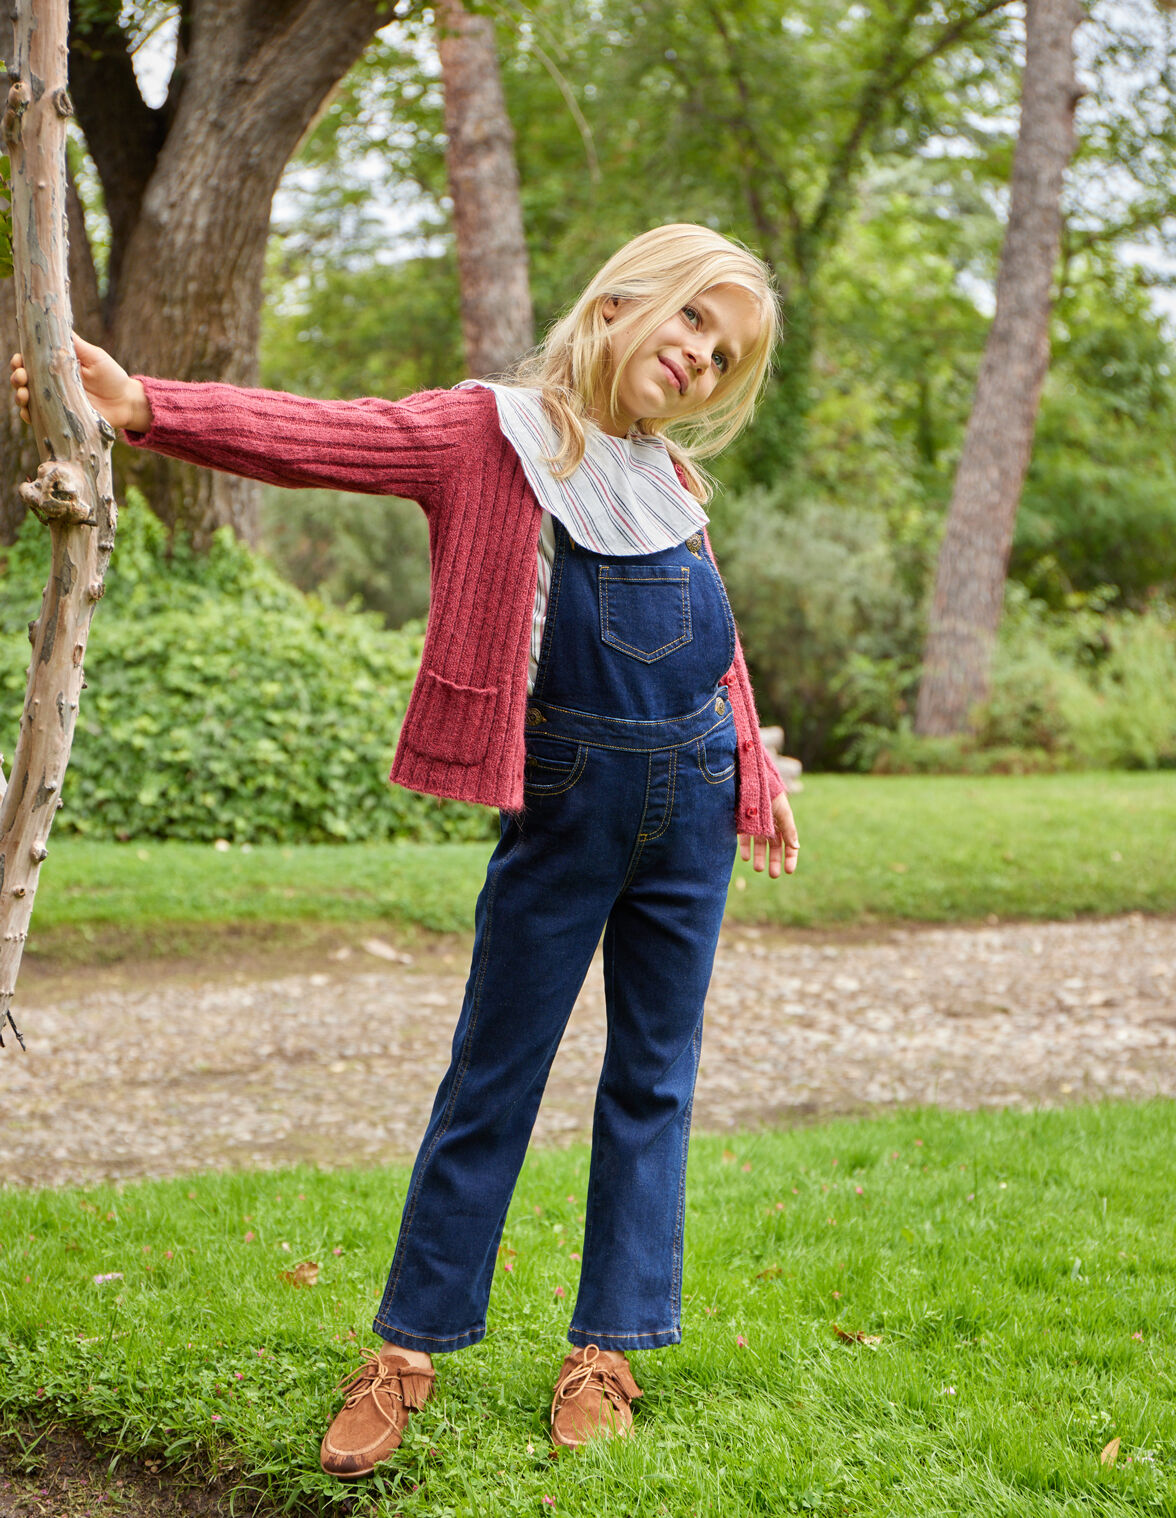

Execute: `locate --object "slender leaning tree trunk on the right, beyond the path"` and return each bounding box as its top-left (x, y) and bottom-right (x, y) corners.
top-left (915, 0), bottom-right (1083, 736)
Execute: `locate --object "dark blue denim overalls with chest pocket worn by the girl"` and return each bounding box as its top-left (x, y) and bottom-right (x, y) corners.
top-left (375, 522), bottom-right (736, 1353)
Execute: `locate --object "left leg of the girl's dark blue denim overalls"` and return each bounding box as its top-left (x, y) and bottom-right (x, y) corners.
top-left (373, 806), bottom-right (619, 1354)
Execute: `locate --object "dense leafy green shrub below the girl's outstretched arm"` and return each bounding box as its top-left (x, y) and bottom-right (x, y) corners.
top-left (0, 492), bottom-right (495, 842)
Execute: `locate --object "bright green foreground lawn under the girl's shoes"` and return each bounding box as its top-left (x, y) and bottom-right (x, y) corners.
top-left (0, 1102), bottom-right (1176, 1518)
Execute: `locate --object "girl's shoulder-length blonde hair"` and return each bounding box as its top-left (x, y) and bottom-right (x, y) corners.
top-left (502, 222), bottom-right (780, 501)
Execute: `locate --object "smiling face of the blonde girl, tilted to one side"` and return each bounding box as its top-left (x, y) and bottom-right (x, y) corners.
top-left (596, 284), bottom-right (760, 437)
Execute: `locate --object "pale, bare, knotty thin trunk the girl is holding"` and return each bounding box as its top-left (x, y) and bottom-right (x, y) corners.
top-left (0, 0), bottom-right (117, 1044)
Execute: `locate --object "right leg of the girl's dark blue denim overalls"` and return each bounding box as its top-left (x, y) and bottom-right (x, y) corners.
top-left (568, 752), bottom-right (734, 1350)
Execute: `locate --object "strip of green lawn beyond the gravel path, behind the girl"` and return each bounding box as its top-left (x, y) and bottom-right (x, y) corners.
top-left (22, 773), bottom-right (1176, 959)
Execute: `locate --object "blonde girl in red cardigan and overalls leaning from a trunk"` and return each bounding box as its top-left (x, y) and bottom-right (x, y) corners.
top-left (12, 225), bottom-right (798, 1477)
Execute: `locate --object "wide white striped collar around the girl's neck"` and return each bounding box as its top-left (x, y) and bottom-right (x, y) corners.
top-left (457, 380), bottom-right (709, 559)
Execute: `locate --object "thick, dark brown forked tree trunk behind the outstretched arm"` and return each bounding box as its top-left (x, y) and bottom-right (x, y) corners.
top-left (57, 0), bottom-right (390, 546)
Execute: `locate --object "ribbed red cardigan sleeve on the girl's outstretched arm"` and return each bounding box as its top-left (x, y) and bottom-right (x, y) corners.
top-left (126, 375), bottom-right (470, 509)
